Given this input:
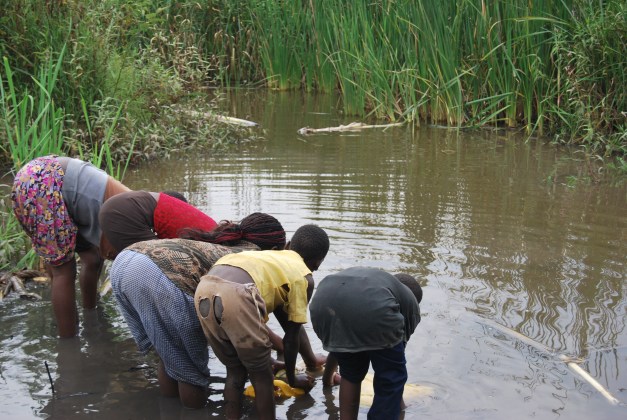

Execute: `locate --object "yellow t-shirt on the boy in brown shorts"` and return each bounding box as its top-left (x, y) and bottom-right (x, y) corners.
top-left (214, 250), bottom-right (311, 324)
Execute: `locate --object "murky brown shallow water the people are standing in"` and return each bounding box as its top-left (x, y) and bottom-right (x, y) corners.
top-left (0, 93), bottom-right (627, 419)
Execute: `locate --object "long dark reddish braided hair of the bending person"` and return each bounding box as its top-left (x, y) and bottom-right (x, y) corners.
top-left (179, 213), bottom-right (285, 249)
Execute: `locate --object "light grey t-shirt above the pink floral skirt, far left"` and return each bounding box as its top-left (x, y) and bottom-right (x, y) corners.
top-left (59, 157), bottom-right (109, 247)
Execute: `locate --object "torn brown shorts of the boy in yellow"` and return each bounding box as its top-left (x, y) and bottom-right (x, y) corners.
top-left (194, 274), bottom-right (272, 371)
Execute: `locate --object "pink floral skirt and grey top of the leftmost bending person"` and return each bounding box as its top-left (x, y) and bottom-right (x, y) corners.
top-left (11, 155), bottom-right (129, 265)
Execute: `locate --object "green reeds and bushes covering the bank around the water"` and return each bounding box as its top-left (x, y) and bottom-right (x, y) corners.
top-left (0, 0), bottom-right (627, 270)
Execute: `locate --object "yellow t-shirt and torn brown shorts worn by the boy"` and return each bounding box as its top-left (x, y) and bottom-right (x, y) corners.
top-left (194, 250), bottom-right (311, 371)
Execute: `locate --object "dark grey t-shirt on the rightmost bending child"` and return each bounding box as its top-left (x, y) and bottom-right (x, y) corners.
top-left (309, 267), bottom-right (420, 353)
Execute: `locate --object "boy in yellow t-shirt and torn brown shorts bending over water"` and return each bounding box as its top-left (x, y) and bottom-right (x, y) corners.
top-left (194, 225), bottom-right (329, 419)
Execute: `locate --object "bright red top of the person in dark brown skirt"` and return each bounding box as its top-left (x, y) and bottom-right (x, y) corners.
top-left (154, 193), bottom-right (218, 239)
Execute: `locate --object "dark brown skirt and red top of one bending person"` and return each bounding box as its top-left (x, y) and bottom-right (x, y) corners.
top-left (99, 191), bottom-right (218, 258)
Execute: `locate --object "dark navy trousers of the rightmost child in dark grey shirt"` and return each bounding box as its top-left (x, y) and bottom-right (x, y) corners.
top-left (333, 342), bottom-right (407, 420)
